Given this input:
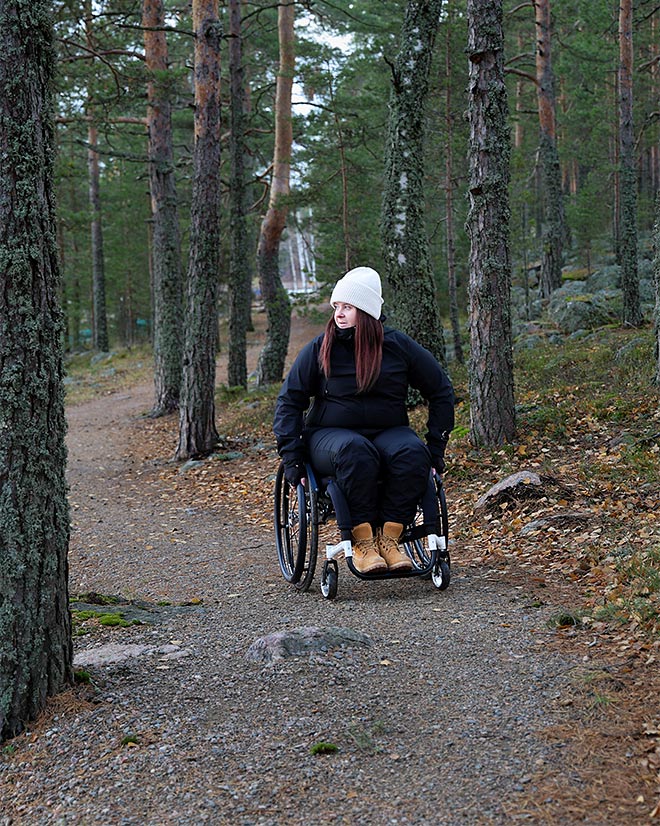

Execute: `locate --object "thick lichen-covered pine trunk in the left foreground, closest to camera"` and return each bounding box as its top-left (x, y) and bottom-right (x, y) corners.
top-left (0, 0), bottom-right (73, 739)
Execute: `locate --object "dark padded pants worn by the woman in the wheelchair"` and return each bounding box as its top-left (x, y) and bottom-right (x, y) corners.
top-left (307, 427), bottom-right (431, 526)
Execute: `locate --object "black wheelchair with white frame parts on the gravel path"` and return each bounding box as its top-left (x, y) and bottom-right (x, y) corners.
top-left (274, 463), bottom-right (451, 599)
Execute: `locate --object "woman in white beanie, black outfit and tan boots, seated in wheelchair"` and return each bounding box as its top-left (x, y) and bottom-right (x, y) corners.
top-left (273, 267), bottom-right (454, 574)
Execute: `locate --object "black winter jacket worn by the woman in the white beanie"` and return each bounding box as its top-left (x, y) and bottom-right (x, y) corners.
top-left (273, 327), bottom-right (454, 474)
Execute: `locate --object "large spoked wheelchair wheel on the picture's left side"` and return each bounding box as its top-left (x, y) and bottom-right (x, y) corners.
top-left (274, 465), bottom-right (318, 591)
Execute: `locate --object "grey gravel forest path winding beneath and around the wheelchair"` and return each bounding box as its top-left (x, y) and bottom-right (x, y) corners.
top-left (0, 318), bottom-right (650, 826)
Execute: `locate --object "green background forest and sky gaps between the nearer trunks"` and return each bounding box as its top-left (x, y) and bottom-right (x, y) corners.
top-left (56, 0), bottom-right (660, 356)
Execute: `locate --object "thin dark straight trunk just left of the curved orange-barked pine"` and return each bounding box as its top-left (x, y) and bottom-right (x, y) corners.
top-left (227, 0), bottom-right (252, 387)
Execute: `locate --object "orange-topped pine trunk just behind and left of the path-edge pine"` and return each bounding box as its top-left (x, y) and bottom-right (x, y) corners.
top-left (142, 0), bottom-right (183, 416)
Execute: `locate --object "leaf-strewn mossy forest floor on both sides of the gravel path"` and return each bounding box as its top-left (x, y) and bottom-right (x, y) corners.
top-left (68, 316), bottom-right (660, 822)
